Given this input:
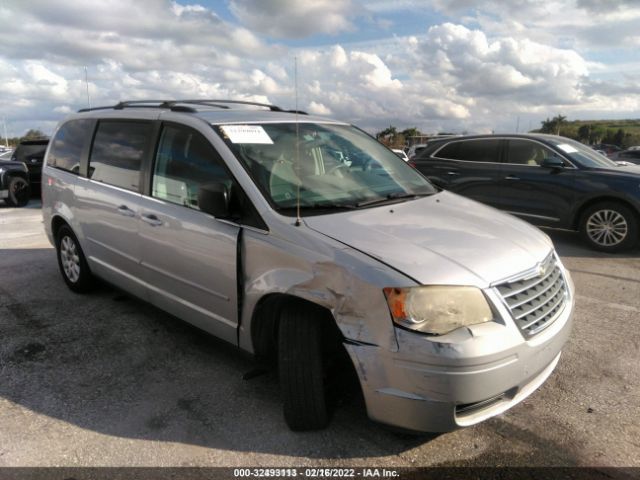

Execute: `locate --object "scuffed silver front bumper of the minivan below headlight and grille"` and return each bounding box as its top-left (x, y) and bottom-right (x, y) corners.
top-left (346, 276), bottom-right (574, 432)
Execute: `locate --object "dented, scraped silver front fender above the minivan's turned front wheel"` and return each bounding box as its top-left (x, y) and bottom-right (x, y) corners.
top-left (238, 223), bottom-right (413, 353)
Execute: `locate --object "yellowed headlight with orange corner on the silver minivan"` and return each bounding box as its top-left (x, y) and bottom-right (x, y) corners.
top-left (384, 286), bottom-right (493, 335)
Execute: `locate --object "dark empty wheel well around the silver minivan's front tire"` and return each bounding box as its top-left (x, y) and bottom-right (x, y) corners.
top-left (251, 293), bottom-right (343, 363)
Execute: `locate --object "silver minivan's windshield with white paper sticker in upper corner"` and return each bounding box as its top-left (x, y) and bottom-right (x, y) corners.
top-left (215, 123), bottom-right (437, 215)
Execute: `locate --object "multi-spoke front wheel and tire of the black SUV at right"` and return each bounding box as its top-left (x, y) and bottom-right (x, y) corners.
top-left (580, 202), bottom-right (638, 253)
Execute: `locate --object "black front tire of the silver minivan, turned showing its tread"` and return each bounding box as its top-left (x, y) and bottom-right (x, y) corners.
top-left (278, 302), bottom-right (329, 431)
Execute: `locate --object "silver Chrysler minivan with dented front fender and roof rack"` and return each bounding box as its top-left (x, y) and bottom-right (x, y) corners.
top-left (42, 100), bottom-right (574, 432)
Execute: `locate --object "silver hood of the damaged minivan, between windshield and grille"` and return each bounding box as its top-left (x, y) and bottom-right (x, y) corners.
top-left (304, 192), bottom-right (553, 287)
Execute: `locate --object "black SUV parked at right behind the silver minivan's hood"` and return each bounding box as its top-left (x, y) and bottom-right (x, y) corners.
top-left (412, 134), bottom-right (640, 252)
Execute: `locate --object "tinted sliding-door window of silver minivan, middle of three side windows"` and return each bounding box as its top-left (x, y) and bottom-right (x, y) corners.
top-left (89, 121), bottom-right (151, 192)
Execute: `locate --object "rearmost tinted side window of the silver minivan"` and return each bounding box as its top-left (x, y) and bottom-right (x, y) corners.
top-left (47, 119), bottom-right (93, 174)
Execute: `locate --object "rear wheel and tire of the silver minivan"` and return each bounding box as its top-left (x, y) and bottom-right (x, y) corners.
top-left (56, 225), bottom-right (94, 293)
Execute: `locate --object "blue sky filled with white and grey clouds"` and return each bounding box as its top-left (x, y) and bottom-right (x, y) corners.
top-left (0, 0), bottom-right (640, 137)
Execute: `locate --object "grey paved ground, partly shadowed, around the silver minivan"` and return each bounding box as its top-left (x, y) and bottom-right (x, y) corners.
top-left (0, 200), bottom-right (640, 467)
